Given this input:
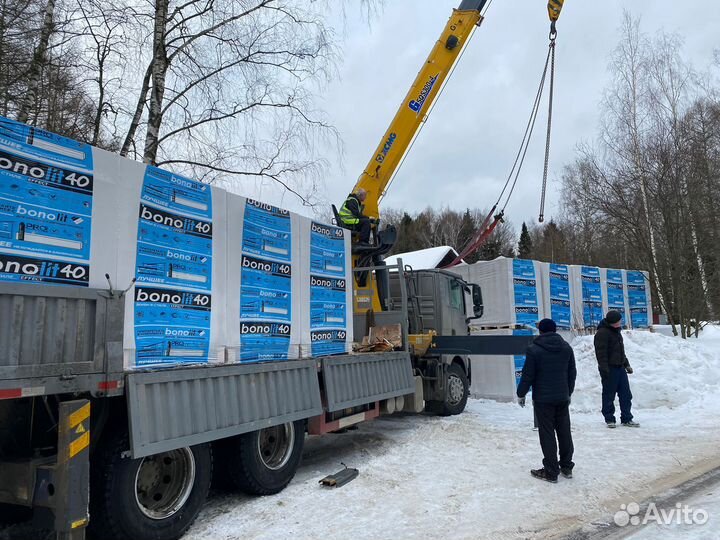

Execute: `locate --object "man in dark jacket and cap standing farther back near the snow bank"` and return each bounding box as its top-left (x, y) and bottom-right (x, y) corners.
top-left (595, 310), bottom-right (640, 428)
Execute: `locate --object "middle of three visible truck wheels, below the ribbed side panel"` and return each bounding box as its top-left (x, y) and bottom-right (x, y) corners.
top-left (228, 420), bottom-right (305, 495)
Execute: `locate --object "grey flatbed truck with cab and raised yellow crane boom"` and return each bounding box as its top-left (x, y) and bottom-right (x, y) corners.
top-left (0, 0), bottom-right (560, 540)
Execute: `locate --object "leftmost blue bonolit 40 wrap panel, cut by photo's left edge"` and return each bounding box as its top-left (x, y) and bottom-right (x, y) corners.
top-left (0, 117), bottom-right (94, 286)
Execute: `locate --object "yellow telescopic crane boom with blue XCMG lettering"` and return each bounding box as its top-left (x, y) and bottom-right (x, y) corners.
top-left (354, 0), bottom-right (487, 218)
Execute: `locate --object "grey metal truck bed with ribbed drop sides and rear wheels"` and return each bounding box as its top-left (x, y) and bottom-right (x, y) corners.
top-left (0, 283), bottom-right (416, 539)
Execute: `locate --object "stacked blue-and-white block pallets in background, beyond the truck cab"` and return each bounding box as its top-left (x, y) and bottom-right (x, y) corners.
top-left (452, 257), bottom-right (652, 401)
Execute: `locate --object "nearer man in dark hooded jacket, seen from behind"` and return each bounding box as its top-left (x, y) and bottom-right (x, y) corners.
top-left (517, 319), bottom-right (577, 483)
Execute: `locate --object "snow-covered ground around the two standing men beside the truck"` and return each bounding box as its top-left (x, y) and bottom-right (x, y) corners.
top-left (186, 328), bottom-right (720, 540)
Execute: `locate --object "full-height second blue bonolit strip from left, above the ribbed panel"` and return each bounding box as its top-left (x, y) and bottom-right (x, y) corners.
top-left (135, 167), bottom-right (213, 366)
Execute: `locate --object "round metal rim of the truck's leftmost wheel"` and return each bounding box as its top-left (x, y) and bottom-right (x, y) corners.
top-left (135, 448), bottom-right (195, 519)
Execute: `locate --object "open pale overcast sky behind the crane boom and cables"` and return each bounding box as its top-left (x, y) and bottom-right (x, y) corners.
top-left (296, 0), bottom-right (720, 225)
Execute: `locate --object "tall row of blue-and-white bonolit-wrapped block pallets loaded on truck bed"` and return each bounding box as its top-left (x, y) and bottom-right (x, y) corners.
top-left (0, 113), bottom-right (352, 369)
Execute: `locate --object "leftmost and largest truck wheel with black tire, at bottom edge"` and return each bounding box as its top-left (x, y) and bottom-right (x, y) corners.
top-left (89, 435), bottom-right (212, 540)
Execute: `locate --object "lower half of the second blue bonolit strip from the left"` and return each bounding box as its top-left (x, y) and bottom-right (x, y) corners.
top-left (135, 286), bottom-right (212, 366)
